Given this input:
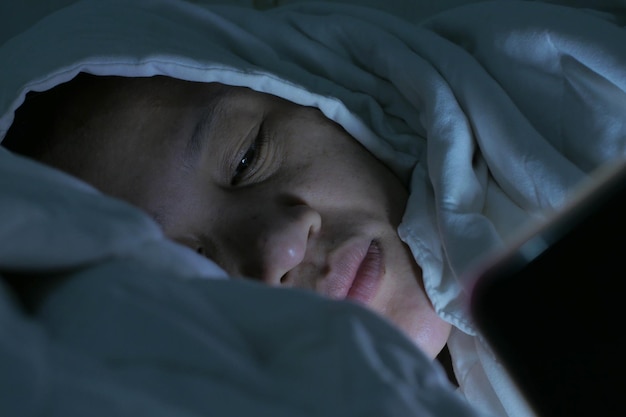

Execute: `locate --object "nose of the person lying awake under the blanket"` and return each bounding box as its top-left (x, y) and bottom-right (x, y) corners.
top-left (244, 204), bottom-right (322, 286)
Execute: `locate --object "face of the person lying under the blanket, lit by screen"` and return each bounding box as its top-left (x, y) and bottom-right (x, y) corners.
top-left (41, 77), bottom-right (450, 358)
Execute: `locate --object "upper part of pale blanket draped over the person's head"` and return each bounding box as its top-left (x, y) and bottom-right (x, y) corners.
top-left (0, 1), bottom-right (626, 416)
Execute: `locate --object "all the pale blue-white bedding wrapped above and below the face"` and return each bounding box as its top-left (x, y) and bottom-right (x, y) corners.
top-left (0, 0), bottom-right (626, 416)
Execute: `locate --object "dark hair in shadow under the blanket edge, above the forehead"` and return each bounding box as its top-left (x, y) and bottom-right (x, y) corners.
top-left (1, 73), bottom-right (200, 184)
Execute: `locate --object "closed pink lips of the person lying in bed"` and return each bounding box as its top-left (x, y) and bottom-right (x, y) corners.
top-left (329, 240), bottom-right (384, 304)
